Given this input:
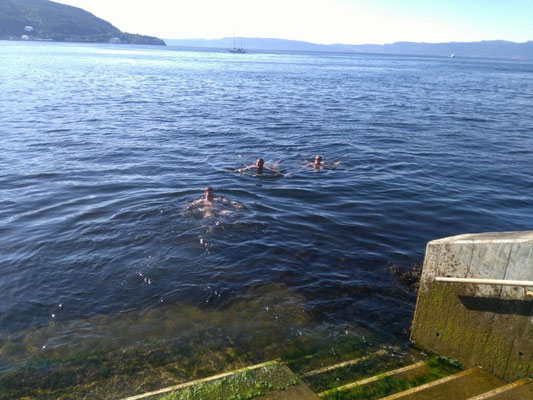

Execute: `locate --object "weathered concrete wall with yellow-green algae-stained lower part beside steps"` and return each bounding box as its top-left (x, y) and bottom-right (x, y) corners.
top-left (411, 231), bottom-right (533, 381)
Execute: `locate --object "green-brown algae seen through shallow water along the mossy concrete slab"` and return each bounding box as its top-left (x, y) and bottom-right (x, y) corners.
top-left (0, 327), bottom-right (384, 400)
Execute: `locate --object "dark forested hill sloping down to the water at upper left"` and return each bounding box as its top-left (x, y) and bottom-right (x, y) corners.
top-left (0, 0), bottom-right (165, 45)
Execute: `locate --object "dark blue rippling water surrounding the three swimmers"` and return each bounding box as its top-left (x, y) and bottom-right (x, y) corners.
top-left (0, 42), bottom-right (533, 370)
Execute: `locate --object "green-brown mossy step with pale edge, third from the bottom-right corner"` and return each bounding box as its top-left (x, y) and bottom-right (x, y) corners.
top-left (319, 357), bottom-right (459, 400)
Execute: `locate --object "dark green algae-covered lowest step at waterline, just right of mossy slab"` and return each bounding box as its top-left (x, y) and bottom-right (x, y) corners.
top-left (302, 351), bottom-right (412, 393)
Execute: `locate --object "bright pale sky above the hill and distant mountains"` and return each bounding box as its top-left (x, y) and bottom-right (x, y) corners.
top-left (55, 0), bottom-right (533, 44)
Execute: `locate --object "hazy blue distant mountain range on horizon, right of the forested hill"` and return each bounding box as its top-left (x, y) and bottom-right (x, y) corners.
top-left (166, 37), bottom-right (533, 59)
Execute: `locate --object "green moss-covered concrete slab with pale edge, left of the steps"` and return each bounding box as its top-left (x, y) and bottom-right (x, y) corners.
top-left (120, 361), bottom-right (317, 400)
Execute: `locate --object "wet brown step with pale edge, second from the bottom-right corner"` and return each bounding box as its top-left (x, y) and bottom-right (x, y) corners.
top-left (376, 367), bottom-right (505, 400)
